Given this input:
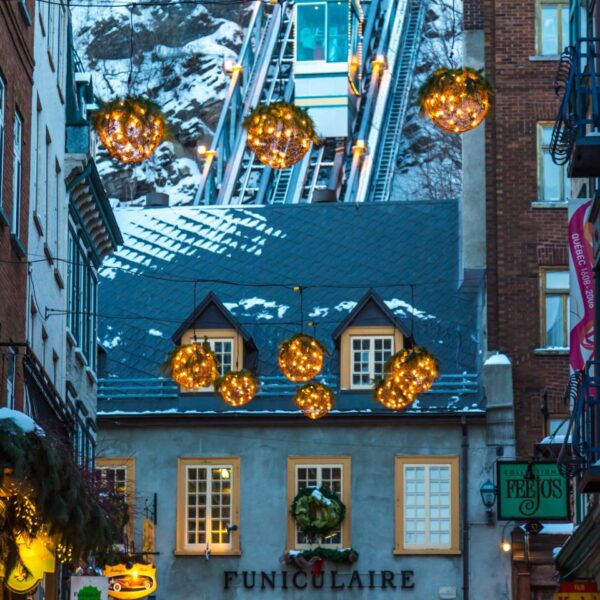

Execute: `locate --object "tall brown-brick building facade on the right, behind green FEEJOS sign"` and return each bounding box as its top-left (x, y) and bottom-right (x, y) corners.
top-left (464, 0), bottom-right (569, 600)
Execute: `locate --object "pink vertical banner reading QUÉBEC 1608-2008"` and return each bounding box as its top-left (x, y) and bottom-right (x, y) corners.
top-left (569, 200), bottom-right (594, 372)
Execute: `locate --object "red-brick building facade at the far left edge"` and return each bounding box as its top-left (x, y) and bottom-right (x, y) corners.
top-left (0, 0), bottom-right (35, 408)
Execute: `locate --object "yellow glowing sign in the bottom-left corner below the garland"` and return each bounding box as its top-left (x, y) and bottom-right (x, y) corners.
top-left (5, 535), bottom-right (56, 594)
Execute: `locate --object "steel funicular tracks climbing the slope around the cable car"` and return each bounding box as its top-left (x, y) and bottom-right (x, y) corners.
top-left (194, 0), bottom-right (426, 205)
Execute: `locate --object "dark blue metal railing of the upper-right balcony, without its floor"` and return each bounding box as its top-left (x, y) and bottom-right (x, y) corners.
top-left (550, 38), bottom-right (600, 165)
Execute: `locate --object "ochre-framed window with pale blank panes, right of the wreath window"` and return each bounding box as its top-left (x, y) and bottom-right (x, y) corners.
top-left (396, 457), bottom-right (458, 553)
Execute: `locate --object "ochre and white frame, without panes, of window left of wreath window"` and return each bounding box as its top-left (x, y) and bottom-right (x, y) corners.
top-left (175, 456), bottom-right (240, 555)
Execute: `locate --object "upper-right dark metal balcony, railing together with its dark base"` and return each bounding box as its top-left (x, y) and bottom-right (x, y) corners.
top-left (550, 38), bottom-right (600, 177)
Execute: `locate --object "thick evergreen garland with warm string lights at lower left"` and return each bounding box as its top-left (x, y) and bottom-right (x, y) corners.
top-left (0, 419), bottom-right (126, 575)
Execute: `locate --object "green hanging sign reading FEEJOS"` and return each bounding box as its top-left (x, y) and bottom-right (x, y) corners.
top-left (497, 461), bottom-right (571, 521)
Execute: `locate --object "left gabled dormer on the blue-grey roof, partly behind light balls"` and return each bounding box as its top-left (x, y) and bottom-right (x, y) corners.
top-left (171, 292), bottom-right (257, 386)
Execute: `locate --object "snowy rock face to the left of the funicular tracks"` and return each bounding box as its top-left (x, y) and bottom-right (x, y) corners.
top-left (72, 2), bottom-right (246, 204)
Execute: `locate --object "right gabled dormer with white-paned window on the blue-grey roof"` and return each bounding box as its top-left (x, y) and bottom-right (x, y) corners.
top-left (332, 290), bottom-right (408, 390)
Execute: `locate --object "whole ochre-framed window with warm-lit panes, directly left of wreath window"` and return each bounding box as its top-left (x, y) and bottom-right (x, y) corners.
top-left (177, 458), bottom-right (240, 554)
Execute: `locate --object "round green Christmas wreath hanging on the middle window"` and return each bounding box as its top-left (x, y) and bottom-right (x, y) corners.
top-left (290, 486), bottom-right (346, 536)
